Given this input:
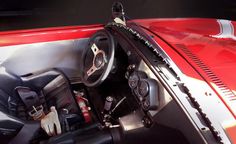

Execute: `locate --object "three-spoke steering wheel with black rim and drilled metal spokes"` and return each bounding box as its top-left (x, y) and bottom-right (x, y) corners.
top-left (82, 29), bottom-right (115, 87)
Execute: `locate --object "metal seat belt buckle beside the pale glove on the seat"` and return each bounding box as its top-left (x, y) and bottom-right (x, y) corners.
top-left (28, 105), bottom-right (45, 120)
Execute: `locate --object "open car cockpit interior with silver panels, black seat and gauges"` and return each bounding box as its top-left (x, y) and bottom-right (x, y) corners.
top-left (0, 22), bottom-right (209, 144)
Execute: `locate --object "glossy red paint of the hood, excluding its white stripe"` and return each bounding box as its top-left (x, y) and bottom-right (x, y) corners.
top-left (135, 19), bottom-right (236, 113)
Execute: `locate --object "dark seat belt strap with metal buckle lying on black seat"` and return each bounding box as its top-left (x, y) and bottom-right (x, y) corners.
top-left (16, 86), bottom-right (45, 120)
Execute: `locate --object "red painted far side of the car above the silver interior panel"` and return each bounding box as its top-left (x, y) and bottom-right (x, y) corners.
top-left (0, 25), bottom-right (102, 46)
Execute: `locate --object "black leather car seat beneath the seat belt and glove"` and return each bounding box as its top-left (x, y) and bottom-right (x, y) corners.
top-left (0, 67), bottom-right (80, 143)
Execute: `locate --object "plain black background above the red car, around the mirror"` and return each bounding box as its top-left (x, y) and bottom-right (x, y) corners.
top-left (0, 0), bottom-right (236, 31)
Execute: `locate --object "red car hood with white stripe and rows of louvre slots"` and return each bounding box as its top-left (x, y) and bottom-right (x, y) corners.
top-left (136, 19), bottom-right (236, 117)
